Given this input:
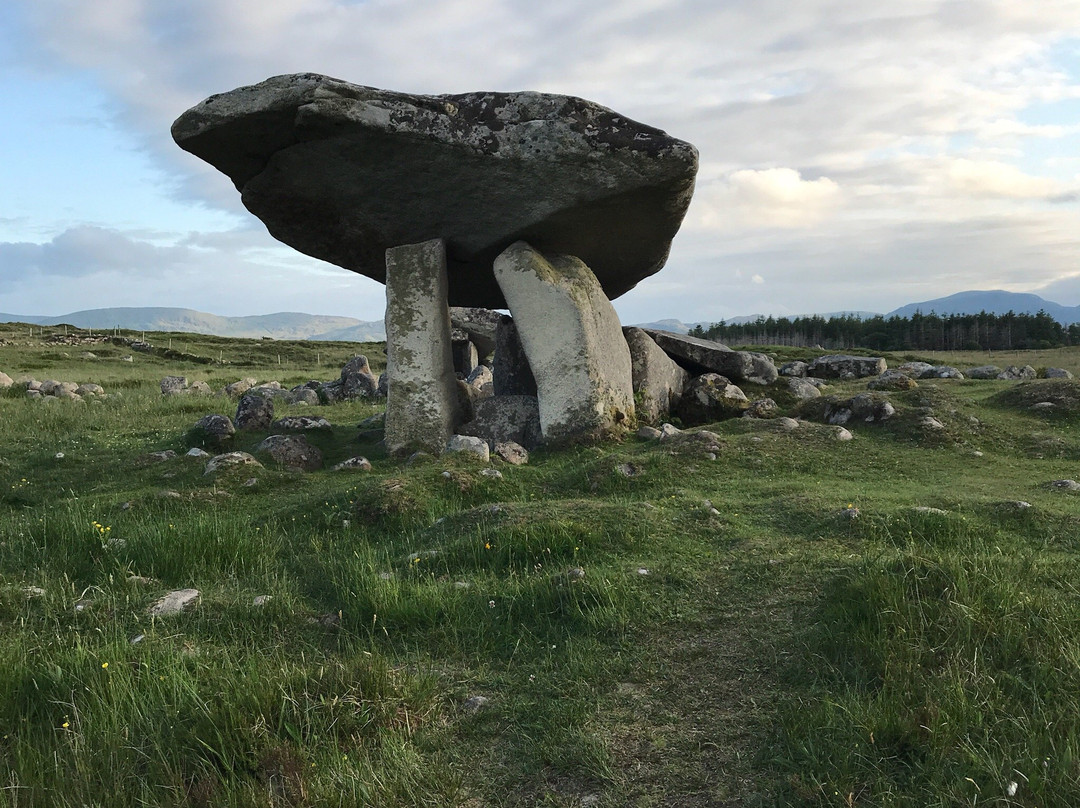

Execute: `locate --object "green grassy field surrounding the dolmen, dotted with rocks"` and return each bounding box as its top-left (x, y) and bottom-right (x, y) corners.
top-left (0, 326), bottom-right (1080, 808)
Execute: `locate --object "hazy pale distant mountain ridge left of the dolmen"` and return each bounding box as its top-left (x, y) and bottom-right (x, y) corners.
top-left (0, 307), bottom-right (386, 342)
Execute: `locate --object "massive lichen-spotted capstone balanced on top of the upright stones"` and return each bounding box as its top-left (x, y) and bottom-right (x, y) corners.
top-left (173, 73), bottom-right (698, 306)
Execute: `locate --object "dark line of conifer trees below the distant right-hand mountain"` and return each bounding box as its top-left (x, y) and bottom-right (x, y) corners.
top-left (690, 311), bottom-right (1080, 351)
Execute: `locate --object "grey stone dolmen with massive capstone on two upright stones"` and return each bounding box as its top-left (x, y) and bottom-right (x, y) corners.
top-left (172, 73), bottom-right (698, 453)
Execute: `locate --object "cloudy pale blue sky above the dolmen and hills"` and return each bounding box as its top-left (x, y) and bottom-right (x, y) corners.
top-left (0, 0), bottom-right (1080, 322)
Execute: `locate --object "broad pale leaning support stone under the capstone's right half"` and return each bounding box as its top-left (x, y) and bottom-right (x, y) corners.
top-left (495, 241), bottom-right (634, 442)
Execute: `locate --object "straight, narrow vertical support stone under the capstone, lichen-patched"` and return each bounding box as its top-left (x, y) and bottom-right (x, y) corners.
top-left (386, 239), bottom-right (465, 454)
